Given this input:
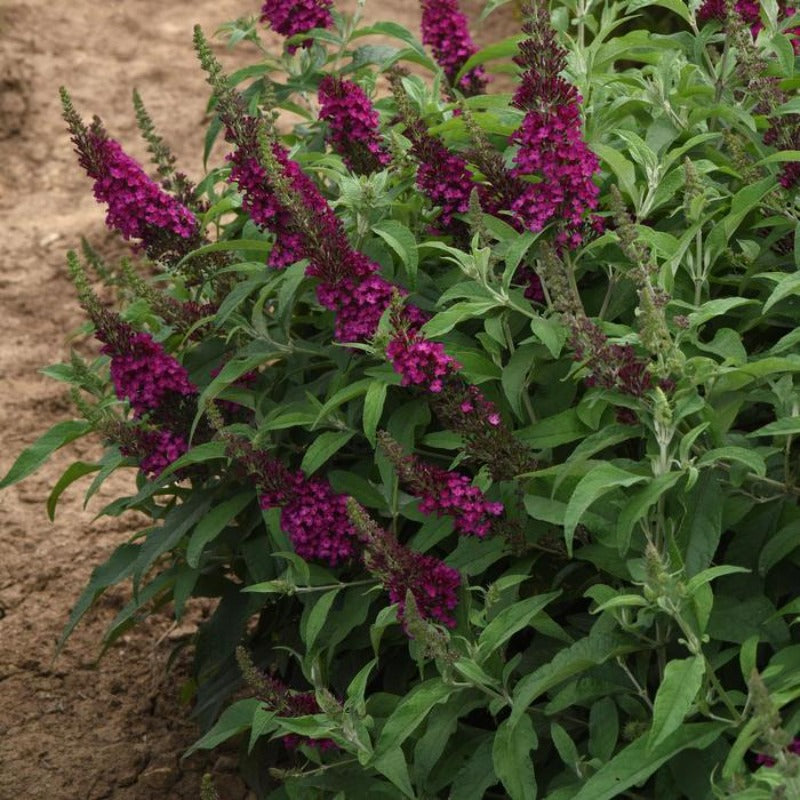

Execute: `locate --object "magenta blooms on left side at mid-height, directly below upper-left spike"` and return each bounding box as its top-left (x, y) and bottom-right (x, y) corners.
top-left (98, 331), bottom-right (197, 417)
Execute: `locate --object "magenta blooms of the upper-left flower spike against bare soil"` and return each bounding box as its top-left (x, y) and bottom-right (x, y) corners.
top-left (81, 130), bottom-right (198, 243)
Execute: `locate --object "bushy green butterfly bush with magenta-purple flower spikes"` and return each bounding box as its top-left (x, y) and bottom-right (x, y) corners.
top-left (3, 0), bottom-right (800, 800)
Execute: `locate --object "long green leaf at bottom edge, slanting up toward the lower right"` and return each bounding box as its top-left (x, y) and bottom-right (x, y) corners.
top-left (572, 722), bottom-right (729, 800)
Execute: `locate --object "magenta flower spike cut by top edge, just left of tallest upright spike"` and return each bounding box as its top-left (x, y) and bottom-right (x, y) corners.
top-left (421, 0), bottom-right (486, 94)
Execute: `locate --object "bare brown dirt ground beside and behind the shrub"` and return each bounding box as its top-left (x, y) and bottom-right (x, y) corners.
top-left (0, 0), bottom-right (509, 800)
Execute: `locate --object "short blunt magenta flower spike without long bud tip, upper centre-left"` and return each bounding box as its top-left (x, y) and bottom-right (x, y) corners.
top-left (318, 75), bottom-right (392, 174)
